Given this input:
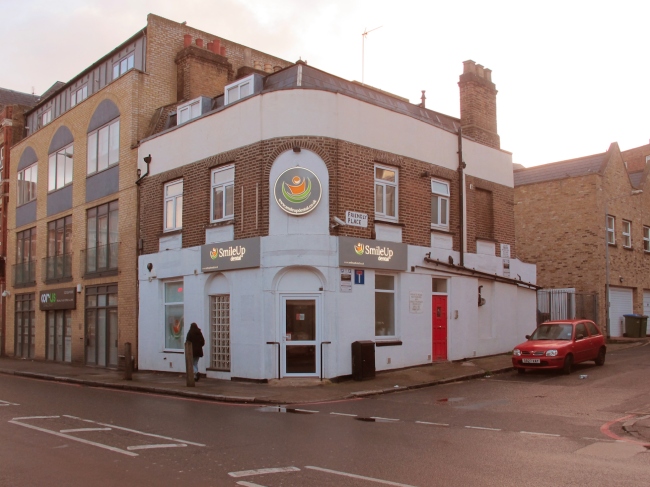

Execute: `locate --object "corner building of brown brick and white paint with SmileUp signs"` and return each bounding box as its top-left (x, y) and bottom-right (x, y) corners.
top-left (138, 61), bottom-right (535, 380)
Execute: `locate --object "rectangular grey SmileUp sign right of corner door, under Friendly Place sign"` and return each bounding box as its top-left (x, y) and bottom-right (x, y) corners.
top-left (339, 237), bottom-right (408, 271)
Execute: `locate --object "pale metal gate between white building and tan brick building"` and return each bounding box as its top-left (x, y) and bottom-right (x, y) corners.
top-left (537, 289), bottom-right (598, 325)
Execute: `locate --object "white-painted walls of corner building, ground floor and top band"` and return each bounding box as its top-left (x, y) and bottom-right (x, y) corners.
top-left (138, 85), bottom-right (536, 380)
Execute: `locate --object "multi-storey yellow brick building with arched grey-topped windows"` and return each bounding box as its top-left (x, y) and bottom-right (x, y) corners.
top-left (5, 15), bottom-right (291, 367)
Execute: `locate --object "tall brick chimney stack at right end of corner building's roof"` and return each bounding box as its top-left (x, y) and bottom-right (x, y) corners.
top-left (458, 60), bottom-right (501, 149)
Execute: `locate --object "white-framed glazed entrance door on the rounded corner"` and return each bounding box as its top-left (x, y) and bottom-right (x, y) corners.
top-left (282, 296), bottom-right (319, 377)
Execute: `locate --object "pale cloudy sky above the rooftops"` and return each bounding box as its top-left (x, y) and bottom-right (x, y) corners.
top-left (0, 0), bottom-right (650, 167)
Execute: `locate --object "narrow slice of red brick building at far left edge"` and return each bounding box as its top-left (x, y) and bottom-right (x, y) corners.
top-left (0, 88), bottom-right (38, 355)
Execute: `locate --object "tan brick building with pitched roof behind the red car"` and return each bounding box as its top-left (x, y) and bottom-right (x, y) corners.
top-left (514, 143), bottom-right (650, 337)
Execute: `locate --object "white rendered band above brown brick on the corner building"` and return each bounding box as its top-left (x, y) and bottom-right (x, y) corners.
top-left (138, 89), bottom-right (514, 187)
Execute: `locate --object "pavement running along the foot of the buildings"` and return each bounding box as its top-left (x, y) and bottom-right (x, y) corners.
top-left (0, 338), bottom-right (650, 408)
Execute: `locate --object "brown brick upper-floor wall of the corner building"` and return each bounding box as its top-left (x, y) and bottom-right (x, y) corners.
top-left (140, 137), bottom-right (515, 258)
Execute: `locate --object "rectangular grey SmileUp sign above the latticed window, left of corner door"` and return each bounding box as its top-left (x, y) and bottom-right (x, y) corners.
top-left (201, 237), bottom-right (260, 272)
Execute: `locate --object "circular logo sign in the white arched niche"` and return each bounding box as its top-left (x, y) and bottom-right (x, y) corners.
top-left (274, 167), bottom-right (323, 216)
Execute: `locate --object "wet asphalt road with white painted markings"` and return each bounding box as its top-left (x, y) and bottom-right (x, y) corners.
top-left (0, 346), bottom-right (650, 487)
